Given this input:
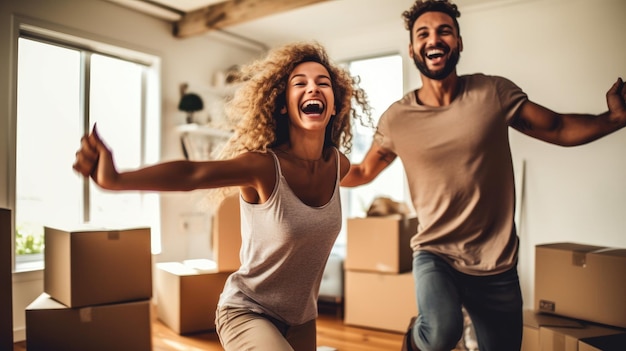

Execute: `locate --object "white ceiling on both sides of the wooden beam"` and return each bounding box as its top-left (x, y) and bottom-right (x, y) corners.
top-left (106, 0), bottom-right (502, 48)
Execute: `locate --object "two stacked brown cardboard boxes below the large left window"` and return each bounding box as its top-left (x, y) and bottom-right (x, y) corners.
top-left (26, 227), bottom-right (152, 351)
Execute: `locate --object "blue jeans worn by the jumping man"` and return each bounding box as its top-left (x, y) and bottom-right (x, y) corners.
top-left (412, 251), bottom-right (523, 351)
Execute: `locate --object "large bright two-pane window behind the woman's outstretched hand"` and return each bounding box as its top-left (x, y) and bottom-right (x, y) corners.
top-left (15, 31), bottom-right (160, 271)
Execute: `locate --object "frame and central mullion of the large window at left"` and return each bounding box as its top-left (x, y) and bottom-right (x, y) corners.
top-left (7, 23), bottom-right (162, 273)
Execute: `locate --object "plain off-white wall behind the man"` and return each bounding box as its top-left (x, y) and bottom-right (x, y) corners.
top-left (324, 0), bottom-right (626, 308)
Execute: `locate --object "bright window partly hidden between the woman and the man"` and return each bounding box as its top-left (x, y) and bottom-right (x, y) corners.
top-left (337, 55), bottom-right (408, 246)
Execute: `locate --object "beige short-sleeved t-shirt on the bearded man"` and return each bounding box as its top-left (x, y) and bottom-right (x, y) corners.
top-left (377, 74), bottom-right (528, 275)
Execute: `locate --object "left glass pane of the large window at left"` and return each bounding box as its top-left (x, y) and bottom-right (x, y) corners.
top-left (15, 38), bottom-right (82, 262)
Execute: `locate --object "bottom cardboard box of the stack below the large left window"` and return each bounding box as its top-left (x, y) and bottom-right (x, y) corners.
top-left (26, 293), bottom-right (152, 351)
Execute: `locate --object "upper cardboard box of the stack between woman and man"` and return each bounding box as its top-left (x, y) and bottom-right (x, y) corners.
top-left (345, 215), bottom-right (417, 273)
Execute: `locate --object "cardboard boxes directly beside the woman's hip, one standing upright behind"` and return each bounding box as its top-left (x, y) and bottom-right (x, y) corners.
top-left (154, 195), bottom-right (241, 334)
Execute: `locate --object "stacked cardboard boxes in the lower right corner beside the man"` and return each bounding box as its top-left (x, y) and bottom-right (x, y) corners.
top-left (522, 243), bottom-right (626, 351)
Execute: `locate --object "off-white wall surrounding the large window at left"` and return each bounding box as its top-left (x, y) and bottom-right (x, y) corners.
top-left (0, 0), bottom-right (258, 340)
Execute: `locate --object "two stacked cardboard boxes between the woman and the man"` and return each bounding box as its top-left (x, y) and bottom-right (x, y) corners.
top-left (344, 215), bottom-right (417, 333)
